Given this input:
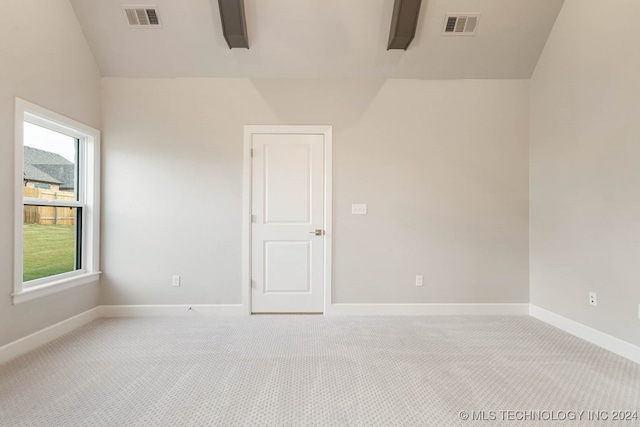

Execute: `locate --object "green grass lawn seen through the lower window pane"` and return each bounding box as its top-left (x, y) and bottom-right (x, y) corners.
top-left (22, 224), bottom-right (76, 282)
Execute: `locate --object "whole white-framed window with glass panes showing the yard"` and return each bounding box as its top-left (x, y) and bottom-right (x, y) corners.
top-left (13, 98), bottom-right (100, 304)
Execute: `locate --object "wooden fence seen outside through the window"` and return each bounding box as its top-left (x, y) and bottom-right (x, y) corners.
top-left (23, 187), bottom-right (76, 225)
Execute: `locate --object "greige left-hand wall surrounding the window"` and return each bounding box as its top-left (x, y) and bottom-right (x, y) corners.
top-left (0, 0), bottom-right (100, 346)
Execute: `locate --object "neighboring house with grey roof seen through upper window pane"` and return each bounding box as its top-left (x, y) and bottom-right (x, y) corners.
top-left (23, 146), bottom-right (75, 191)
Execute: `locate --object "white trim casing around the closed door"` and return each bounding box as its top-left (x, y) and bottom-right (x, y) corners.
top-left (242, 125), bottom-right (333, 315)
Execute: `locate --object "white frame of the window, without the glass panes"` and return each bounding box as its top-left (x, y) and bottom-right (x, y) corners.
top-left (11, 98), bottom-right (100, 305)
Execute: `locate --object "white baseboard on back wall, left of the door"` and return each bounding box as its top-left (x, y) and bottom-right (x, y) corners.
top-left (100, 304), bottom-right (246, 317)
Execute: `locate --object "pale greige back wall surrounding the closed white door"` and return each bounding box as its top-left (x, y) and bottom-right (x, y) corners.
top-left (102, 78), bottom-right (529, 304)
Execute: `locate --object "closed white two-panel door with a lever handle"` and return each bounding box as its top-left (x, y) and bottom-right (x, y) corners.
top-left (251, 133), bottom-right (325, 313)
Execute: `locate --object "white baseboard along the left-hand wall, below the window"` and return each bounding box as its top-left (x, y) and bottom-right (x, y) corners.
top-left (0, 307), bottom-right (100, 364)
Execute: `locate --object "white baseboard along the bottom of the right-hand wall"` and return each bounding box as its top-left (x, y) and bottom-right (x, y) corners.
top-left (529, 304), bottom-right (640, 363)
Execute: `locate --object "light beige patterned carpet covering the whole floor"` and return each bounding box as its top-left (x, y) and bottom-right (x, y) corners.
top-left (0, 316), bottom-right (640, 426)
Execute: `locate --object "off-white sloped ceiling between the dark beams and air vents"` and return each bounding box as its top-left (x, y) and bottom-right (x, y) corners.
top-left (70, 0), bottom-right (564, 79)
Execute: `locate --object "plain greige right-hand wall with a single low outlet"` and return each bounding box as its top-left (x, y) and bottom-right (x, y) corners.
top-left (530, 0), bottom-right (640, 345)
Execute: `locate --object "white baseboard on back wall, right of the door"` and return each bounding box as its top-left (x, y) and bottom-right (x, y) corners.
top-left (327, 303), bottom-right (529, 316)
